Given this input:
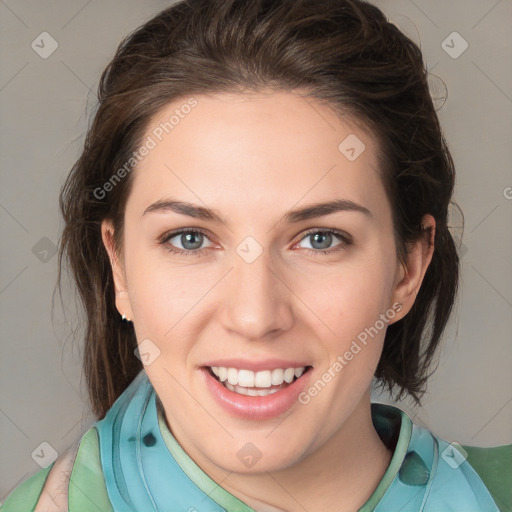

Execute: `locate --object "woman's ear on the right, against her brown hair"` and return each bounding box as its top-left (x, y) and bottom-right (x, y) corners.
top-left (391, 214), bottom-right (436, 323)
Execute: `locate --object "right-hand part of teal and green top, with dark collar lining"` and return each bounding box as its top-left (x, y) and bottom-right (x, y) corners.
top-left (372, 404), bottom-right (512, 512)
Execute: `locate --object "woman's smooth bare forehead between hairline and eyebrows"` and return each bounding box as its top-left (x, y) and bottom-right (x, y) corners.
top-left (127, 92), bottom-right (383, 219)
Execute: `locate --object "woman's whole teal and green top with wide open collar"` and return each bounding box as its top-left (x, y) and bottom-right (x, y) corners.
top-left (0, 370), bottom-right (504, 512)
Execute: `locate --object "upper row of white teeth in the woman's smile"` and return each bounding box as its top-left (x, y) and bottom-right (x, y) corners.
top-left (211, 366), bottom-right (305, 388)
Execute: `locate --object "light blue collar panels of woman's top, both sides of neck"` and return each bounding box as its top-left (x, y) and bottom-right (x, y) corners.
top-left (95, 370), bottom-right (499, 512)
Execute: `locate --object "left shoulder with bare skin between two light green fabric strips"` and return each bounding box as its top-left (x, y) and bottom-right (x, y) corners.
top-left (0, 427), bottom-right (112, 512)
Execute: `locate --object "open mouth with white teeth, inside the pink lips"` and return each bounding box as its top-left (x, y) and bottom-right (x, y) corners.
top-left (204, 365), bottom-right (313, 397)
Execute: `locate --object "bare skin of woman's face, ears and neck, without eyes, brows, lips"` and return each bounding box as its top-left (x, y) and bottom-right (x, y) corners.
top-left (102, 91), bottom-right (435, 512)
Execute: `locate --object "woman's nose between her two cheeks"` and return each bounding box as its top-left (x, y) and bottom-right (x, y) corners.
top-left (222, 251), bottom-right (293, 341)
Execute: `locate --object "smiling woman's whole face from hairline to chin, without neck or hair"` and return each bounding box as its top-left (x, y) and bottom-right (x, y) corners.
top-left (103, 92), bottom-right (424, 472)
